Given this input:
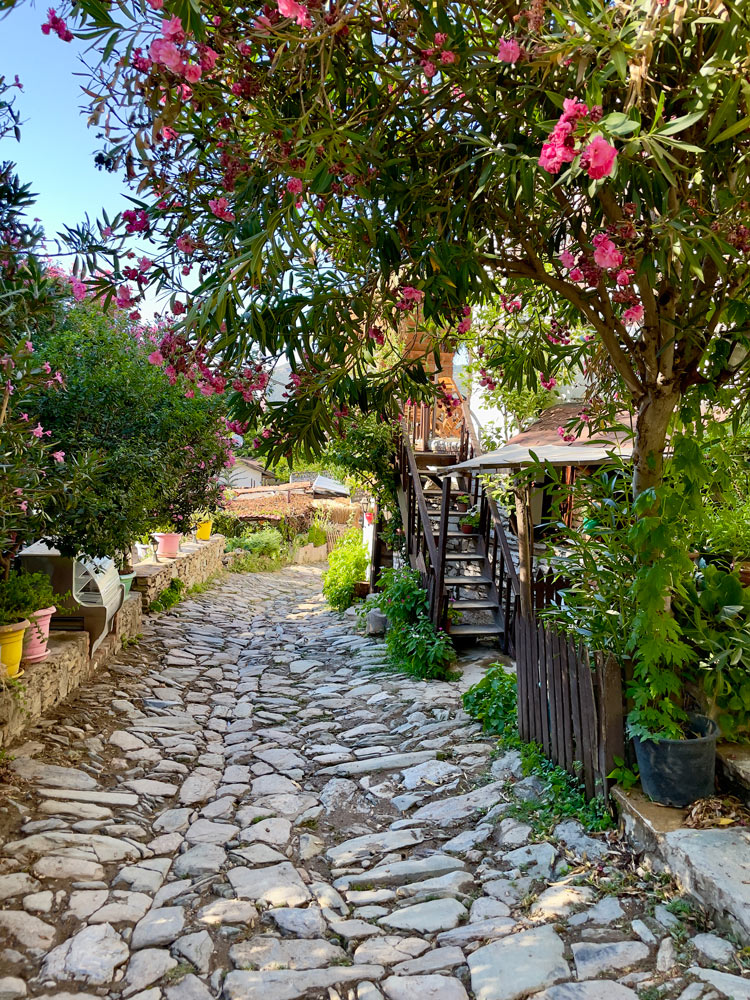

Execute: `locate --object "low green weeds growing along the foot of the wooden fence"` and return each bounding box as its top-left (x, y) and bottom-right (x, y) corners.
top-left (463, 663), bottom-right (613, 834)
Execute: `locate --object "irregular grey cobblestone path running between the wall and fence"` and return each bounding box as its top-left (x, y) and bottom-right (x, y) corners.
top-left (0, 567), bottom-right (750, 1000)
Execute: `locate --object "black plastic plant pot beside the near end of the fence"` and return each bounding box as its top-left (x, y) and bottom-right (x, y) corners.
top-left (633, 715), bottom-right (719, 808)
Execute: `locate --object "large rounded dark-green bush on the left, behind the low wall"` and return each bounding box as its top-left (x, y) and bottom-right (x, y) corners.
top-left (27, 302), bottom-right (231, 556)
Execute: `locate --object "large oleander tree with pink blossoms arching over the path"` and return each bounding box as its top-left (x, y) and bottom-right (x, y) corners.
top-left (10, 0), bottom-right (750, 494)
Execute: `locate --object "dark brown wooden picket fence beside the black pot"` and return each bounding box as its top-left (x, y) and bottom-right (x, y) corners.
top-left (515, 615), bottom-right (625, 798)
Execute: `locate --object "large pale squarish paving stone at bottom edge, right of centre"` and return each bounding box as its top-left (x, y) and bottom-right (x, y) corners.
top-left (468, 924), bottom-right (570, 1000)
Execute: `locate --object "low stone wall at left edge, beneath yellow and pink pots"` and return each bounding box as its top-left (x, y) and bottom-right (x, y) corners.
top-left (0, 594), bottom-right (142, 746)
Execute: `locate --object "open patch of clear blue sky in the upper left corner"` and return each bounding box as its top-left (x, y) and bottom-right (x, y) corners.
top-left (0, 2), bottom-right (132, 246)
